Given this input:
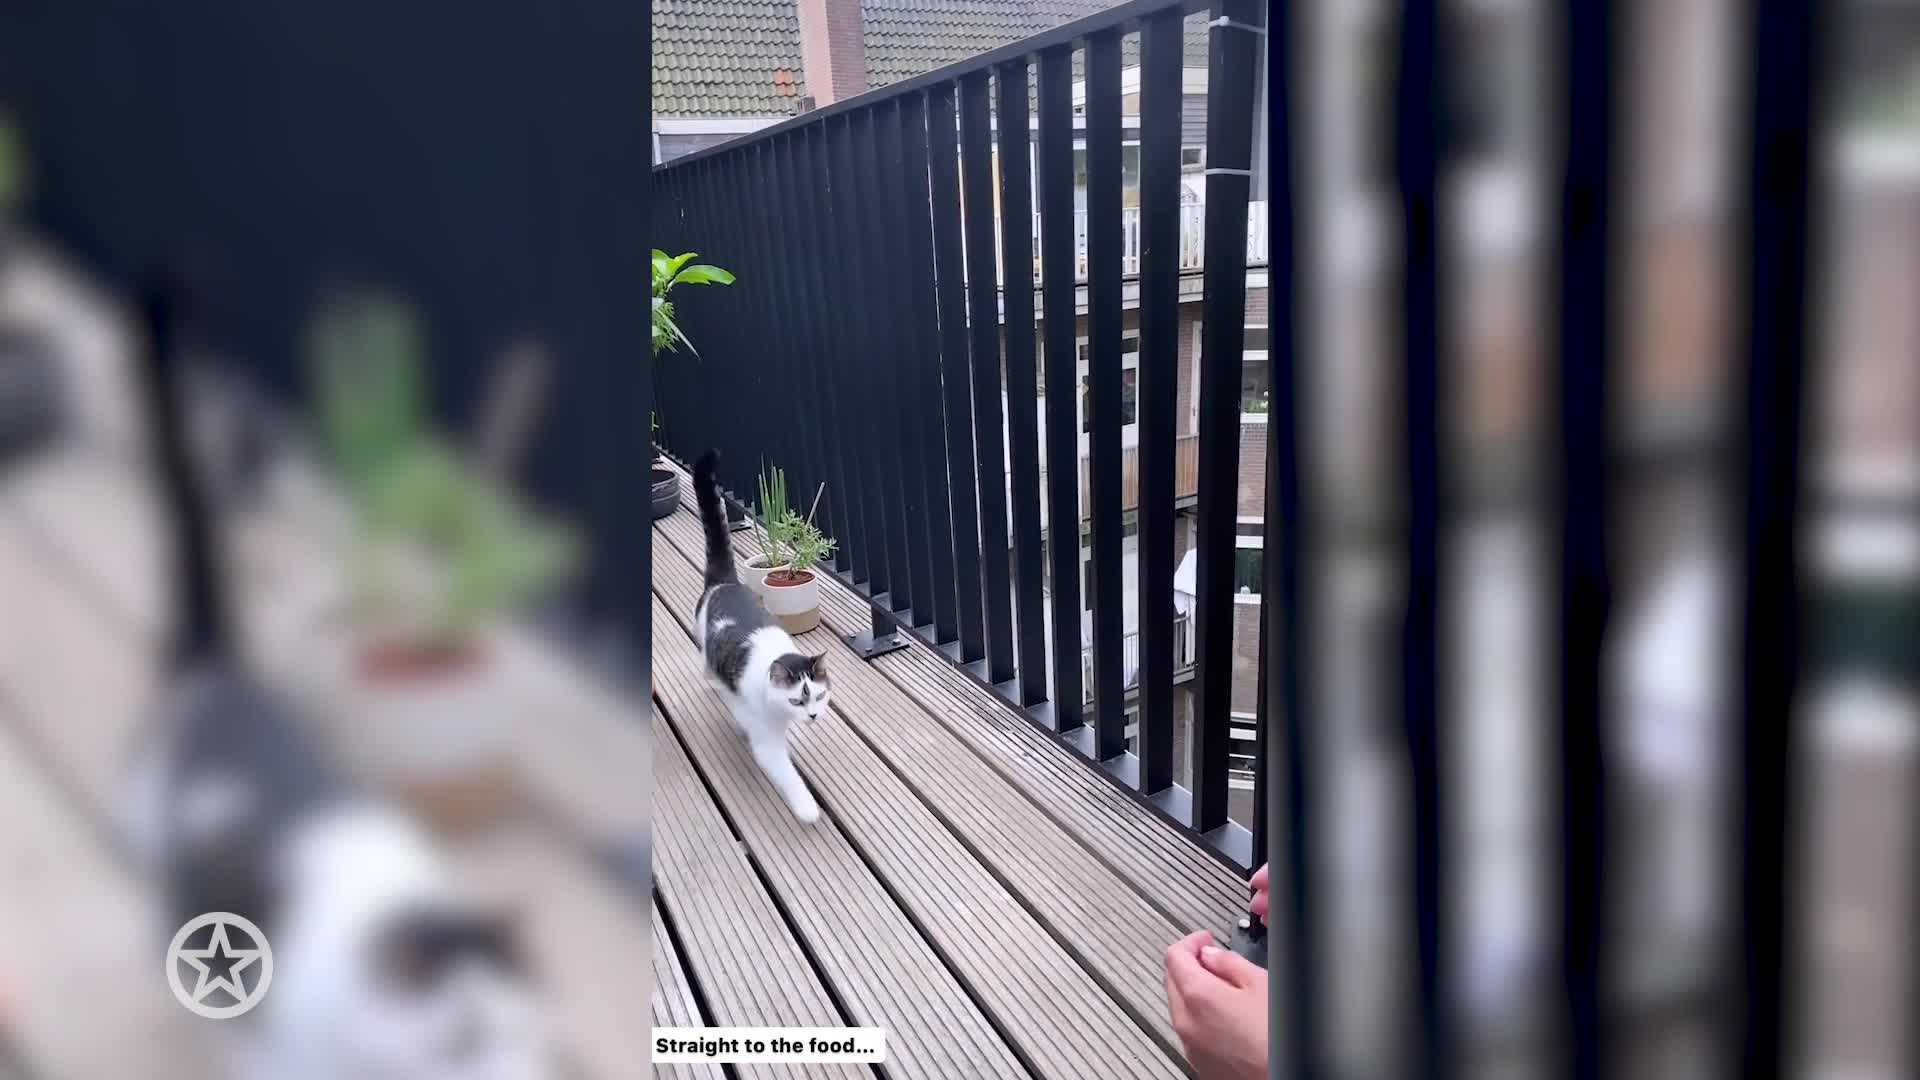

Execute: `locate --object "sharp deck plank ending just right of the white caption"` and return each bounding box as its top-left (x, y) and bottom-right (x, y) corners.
top-left (653, 615), bottom-right (1023, 1078)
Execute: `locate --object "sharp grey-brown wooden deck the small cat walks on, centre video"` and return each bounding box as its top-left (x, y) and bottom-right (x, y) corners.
top-left (653, 465), bottom-right (1246, 1080)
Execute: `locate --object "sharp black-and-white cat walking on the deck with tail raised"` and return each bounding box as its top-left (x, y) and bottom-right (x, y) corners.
top-left (693, 450), bottom-right (833, 824)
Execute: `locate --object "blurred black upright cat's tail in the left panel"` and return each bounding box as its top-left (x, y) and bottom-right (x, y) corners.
top-left (142, 278), bottom-right (232, 667)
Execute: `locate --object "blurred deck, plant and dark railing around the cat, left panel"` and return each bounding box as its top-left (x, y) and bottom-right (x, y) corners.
top-left (0, 0), bottom-right (653, 1080)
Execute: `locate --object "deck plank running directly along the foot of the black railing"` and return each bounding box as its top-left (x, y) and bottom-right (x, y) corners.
top-left (655, 475), bottom-right (1246, 934)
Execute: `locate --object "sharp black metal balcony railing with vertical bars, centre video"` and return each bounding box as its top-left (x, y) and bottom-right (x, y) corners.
top-left (655, 0), bottom-right (1265, 871)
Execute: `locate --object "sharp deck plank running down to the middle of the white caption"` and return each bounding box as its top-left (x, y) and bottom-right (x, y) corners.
top-left (653, 707), bottom-right (870, 1080)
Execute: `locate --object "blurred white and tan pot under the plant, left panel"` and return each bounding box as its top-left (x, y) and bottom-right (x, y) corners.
top-left (334, 642), bottom-right (518, 830)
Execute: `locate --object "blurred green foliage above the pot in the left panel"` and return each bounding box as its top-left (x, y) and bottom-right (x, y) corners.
top-left (313, 300), bottom-right (576, 648)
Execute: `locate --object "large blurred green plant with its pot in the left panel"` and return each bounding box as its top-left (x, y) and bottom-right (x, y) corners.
top-left (315, 304), bottom-right (576, 826)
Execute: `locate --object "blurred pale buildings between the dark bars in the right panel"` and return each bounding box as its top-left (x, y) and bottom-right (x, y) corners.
top-left (1298, 0), bottom-right (1920, 1078)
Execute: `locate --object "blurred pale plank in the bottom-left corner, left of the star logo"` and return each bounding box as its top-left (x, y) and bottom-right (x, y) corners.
top-left (0, 691), bottom-right (213, 1080)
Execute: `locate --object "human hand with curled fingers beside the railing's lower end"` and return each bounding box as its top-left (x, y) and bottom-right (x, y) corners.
top-left (1165, 930), bottom-right (1267, 1080)
